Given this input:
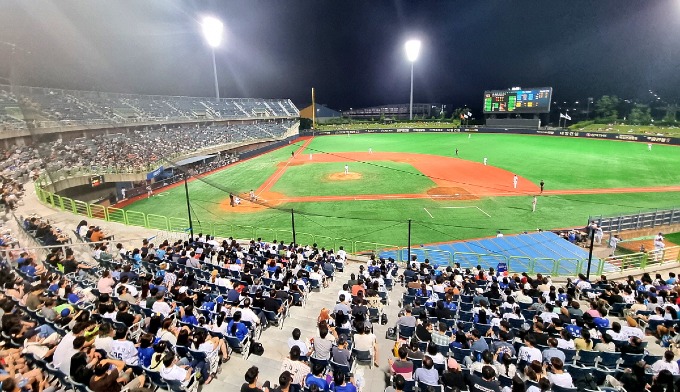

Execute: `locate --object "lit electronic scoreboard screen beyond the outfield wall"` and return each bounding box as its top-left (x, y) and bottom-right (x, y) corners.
top-left (484, 87), bottom-right (552, 113)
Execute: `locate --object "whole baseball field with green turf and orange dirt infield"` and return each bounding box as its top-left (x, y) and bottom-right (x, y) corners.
top-left (119, 133), bottom-right (680, 249)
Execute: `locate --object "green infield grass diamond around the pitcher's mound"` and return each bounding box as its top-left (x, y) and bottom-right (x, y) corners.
top-left (272, 161), bottom-right (435, 196)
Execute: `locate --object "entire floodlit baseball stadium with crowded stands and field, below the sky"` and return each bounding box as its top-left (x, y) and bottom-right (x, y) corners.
top-left (0, 2), bottom-right (680, 392)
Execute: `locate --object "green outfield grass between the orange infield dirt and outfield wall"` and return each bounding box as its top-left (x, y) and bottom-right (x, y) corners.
top-left (306, 133), bottom-right (680, 189)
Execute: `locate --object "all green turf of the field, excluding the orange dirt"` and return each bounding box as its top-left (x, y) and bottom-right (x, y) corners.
top-left (126, 134), bottom-right (680, 247)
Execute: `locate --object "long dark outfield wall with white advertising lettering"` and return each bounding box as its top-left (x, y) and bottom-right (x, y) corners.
top-left (300, 128), bottom-right (680, 146)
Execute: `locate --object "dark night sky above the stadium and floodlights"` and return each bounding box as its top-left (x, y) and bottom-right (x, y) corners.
top-left (0, 0), bottom-right (680, 110)
